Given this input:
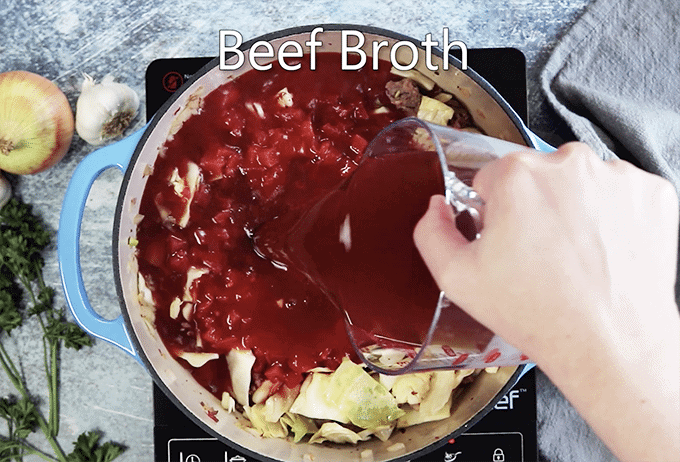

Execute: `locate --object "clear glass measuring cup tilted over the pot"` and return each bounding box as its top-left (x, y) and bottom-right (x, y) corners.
top-left (340, 117), bottom-right (530, 374)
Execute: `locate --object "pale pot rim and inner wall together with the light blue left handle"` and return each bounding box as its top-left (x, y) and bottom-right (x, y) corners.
top-left (57, 24), bottom-right (550, 462)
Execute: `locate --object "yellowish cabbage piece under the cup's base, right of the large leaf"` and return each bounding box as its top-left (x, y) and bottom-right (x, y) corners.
top-left (397, 369), bottom-right (474, 428)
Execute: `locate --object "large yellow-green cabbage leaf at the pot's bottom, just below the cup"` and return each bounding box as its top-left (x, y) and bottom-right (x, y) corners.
top-left (326, 360), bottom-right (404, 428)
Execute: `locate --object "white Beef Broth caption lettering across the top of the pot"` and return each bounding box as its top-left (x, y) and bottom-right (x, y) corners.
top-left (219, 27), bottom-right (467, 72)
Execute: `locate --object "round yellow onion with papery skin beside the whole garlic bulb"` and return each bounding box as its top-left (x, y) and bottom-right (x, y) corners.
top-left (0, 71), bottom-right (74, 175)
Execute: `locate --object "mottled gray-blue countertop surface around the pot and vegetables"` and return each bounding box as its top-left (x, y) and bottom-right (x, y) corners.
top-left (0, 0), bottom-right (610, 461)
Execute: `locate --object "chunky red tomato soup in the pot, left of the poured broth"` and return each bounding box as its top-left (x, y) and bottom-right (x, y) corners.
top-left (137, 53), bottom-right (478, 397)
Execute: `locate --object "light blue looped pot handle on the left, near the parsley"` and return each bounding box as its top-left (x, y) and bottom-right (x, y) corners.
top-left (57, 126), bottom-right (146, 366)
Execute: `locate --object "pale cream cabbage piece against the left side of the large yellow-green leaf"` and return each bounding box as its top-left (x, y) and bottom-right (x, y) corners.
top-left (290, 372), bottom-right (349, 423)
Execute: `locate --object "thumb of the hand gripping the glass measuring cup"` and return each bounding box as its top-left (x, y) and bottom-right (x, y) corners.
top-left (413, 195), bottom-right (473, 301)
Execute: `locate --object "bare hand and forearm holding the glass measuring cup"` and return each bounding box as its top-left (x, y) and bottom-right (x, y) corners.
top-left (414, 143), bottom-right (680, 460)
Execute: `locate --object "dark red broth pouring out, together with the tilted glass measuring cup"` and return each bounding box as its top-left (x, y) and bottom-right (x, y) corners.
top-left (255, 118), bottom-right (532, 372)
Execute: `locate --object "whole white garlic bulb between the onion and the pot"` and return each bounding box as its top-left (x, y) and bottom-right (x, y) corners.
top-left (76, 74), bottom-right (139, 145)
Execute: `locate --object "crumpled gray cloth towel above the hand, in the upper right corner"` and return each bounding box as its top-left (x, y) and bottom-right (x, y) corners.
top-left (541, 0), bottom-right (680, 302)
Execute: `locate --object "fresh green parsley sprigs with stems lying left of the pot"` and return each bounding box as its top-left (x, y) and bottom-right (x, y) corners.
top-left (0, 198), bottom-right (124, 462)
